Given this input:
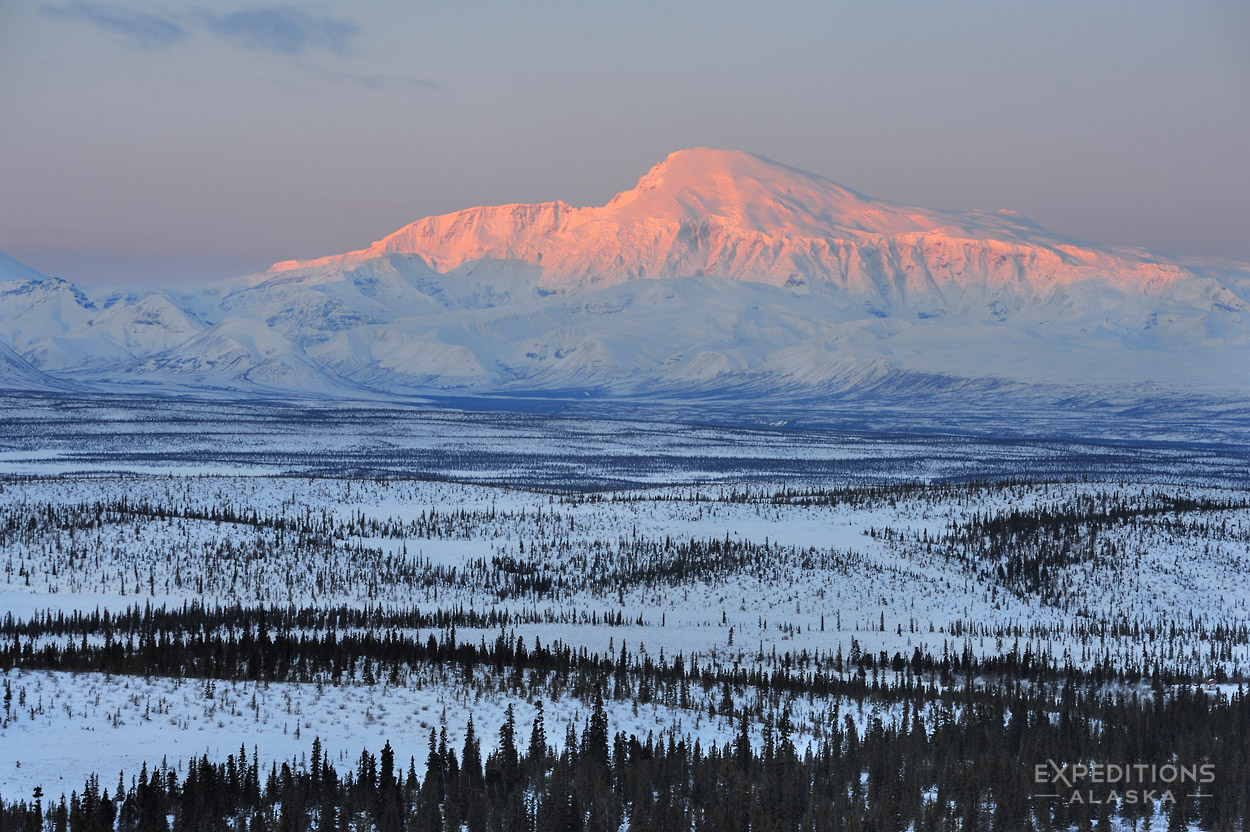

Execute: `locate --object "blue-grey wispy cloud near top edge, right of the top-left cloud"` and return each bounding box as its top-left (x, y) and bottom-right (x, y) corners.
top-left (199, 6), bottom-right (360, 55)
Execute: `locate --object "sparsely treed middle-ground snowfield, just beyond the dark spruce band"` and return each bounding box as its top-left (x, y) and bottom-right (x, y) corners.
top-left (0, 476), bottom-right (1250, 655)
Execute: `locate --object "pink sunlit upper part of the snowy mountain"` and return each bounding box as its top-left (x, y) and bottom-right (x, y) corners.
top-left (270, 147), bottom-right (1180, 294)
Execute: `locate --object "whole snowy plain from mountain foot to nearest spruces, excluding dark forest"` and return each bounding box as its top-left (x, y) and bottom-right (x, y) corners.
top-left (0, 400), bottom-right (1250, 797)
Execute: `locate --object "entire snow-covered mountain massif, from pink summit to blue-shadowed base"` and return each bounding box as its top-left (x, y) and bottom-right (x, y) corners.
top-left (0, 149), bottom-right (1250, 399)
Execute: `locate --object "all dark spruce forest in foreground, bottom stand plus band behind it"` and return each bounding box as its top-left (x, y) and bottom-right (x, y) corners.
top-left (0, 605), bottom-right (1250, 832)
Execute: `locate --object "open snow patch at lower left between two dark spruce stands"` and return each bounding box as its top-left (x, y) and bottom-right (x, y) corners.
top-left (0, 671), bottom-right (770, 800)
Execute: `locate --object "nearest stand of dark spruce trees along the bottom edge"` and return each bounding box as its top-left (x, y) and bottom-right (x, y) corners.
top-left (0, 691), bottom-right (1250, 832)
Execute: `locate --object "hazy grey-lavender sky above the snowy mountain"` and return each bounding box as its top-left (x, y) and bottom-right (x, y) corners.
top-left (0, 0), bottom-right (1250, 285)
